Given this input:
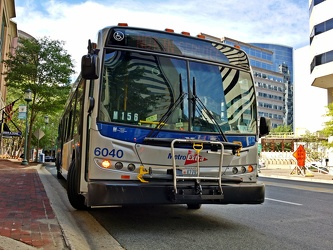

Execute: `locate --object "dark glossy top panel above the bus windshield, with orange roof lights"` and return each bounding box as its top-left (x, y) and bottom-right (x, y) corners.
top-left (97, 25), bottom-right (250, 70)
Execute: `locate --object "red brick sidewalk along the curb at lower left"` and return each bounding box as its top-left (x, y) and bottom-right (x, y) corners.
top-left (0, 159), bottom-right (67, 250)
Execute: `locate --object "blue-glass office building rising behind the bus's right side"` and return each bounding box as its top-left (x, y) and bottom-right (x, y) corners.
top-left (222, 38), bottom-right (294, 129)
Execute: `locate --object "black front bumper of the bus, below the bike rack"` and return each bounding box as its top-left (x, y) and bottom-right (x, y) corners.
top-left (85, 181), bottom-right (265, 207)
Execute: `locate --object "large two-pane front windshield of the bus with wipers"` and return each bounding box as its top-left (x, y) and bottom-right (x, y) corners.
top-left (98, 49), bottom-right (257, 134)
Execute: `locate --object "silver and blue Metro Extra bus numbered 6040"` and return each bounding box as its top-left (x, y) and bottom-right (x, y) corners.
top-left (56, 24), bottom-right (269, 209)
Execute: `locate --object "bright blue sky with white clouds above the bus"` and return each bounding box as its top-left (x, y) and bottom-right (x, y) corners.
top-left (13, 0), bottom-right (309, 74)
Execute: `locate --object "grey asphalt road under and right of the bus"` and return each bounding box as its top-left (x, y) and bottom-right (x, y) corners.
top-left (44, 164), bottom-right (333, 250)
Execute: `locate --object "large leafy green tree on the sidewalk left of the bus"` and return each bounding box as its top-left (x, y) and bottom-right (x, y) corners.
top-left (3, 37), bottom-right (74, 159)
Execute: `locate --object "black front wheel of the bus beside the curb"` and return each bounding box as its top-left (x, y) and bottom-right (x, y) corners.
top-left (67, 161), bottom-right (88, 210)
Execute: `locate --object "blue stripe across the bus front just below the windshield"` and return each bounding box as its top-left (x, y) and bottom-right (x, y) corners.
top-left (97, 123), bottom-right (256, 147)
